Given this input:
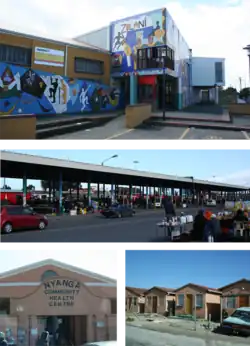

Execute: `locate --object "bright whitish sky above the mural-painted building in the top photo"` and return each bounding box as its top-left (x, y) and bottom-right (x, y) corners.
top-left (0, 0), bottom-right (250, 87)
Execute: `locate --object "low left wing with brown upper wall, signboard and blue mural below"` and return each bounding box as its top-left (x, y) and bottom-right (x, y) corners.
top-left (0, 30), bottom-right (120, 115)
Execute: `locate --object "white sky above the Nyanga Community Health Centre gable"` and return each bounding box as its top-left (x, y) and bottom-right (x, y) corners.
top-left (0, 248), bottom-right (120, 280)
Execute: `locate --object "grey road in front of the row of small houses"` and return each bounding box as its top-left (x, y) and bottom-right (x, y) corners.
top-left (121, 326), bottom-right (249, 346)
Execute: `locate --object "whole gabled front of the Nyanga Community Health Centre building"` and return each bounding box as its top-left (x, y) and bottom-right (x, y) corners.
top-left (0, 260), bottom-right (121, 346)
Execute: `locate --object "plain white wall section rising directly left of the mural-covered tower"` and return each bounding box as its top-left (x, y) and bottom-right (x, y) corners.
top-left (74, 25), bottom-right (110, 50)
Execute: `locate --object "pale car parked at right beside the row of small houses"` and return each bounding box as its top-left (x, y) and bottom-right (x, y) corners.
top-left (221, 307), bottom-right (250, 336)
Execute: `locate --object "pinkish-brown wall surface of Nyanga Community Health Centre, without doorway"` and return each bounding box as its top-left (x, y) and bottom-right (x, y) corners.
top-left (0, 265), bottom-right (120, 346)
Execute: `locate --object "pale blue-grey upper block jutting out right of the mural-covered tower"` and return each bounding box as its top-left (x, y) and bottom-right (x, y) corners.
top-left (192, 57), bottom-right (225, 87)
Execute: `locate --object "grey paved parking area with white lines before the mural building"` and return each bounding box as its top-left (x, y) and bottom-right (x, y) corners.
top-left (48, 116), bottom-right (250, 146)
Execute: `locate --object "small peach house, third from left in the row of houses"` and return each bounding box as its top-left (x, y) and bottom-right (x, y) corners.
top-left (175, 283), bottom-right (221, 321)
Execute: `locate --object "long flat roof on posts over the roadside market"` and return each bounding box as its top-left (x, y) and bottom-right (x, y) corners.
top-left (0, 149), bottom-right (246, 191)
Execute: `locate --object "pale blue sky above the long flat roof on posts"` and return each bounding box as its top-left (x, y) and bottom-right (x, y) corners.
top-left (0, 146), bottom-right (250, 190)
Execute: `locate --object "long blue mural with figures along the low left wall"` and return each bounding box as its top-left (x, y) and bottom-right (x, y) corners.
top-left (0, 63), bottom-right (121, 115)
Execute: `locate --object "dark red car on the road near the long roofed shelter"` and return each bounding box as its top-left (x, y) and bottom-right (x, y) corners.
top-left (0, 205), bottom-right (48, 233)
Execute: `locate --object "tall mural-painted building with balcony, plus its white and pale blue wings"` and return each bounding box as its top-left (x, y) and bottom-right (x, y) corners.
top-left (74, 8), bottom-right (225, 110)
